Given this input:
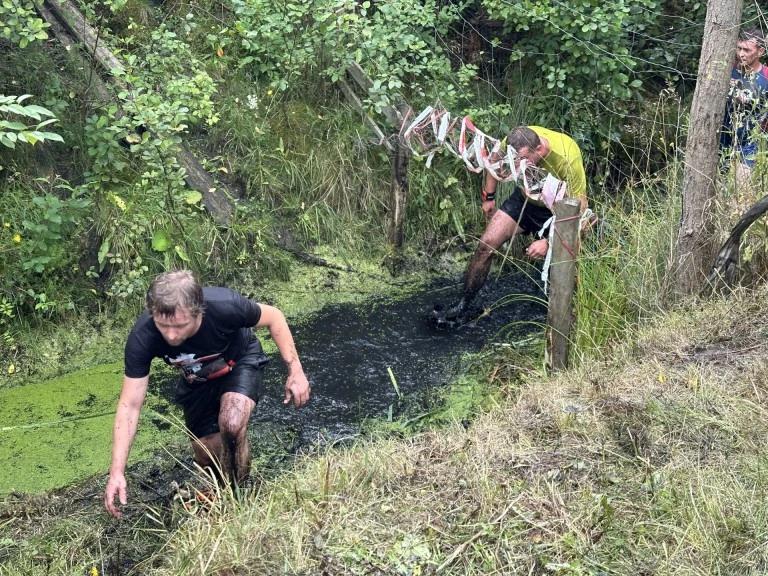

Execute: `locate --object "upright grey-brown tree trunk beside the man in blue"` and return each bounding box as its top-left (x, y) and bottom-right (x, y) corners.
top-left (670, 0), bottom-right (744, 296)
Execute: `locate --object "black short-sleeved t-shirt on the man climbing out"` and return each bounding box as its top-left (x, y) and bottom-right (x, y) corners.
top-left (125, 288), bottom-right (261, 381)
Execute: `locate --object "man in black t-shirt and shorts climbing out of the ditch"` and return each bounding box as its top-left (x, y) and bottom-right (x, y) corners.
top-left (104, 270), bottom-right (310, 518)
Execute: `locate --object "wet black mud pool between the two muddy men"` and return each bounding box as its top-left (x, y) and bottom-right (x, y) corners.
top-left (254, 273), bottom-right (546, 449)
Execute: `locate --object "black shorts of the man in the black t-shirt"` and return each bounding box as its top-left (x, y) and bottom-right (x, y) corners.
top-left (176, 339), bottom-right (269, 438)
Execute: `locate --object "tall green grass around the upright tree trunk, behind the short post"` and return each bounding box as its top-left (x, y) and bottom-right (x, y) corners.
top-left (573, 131), bottom-right (768, 359)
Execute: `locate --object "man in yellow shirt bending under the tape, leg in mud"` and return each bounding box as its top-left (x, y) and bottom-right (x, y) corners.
top-left (435, 126), bottom-right (587, 325)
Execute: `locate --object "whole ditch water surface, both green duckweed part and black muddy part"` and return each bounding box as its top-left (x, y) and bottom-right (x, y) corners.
top-left (0, 273), bottom-right (545, 495)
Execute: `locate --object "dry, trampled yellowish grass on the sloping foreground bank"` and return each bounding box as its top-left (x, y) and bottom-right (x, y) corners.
top-left (0, 289), bottom-right (768, 576)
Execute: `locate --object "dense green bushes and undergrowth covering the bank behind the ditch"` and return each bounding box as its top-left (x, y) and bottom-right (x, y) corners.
top-left (0, 0), bottom-right (744, 360)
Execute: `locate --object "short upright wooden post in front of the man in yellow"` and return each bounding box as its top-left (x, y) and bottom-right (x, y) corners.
top-left (546, 199), bottom-right (581, 372)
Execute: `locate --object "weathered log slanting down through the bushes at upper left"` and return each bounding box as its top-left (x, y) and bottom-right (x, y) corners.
top-left (39, 0), bottom-right (234, 226)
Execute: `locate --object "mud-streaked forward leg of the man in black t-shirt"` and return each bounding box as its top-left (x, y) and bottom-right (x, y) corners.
top-left (219, 392), bottom-right (256, 488)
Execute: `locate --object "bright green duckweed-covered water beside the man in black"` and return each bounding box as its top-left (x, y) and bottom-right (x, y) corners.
top-left (0, 362), bottom-right (183, 496)
